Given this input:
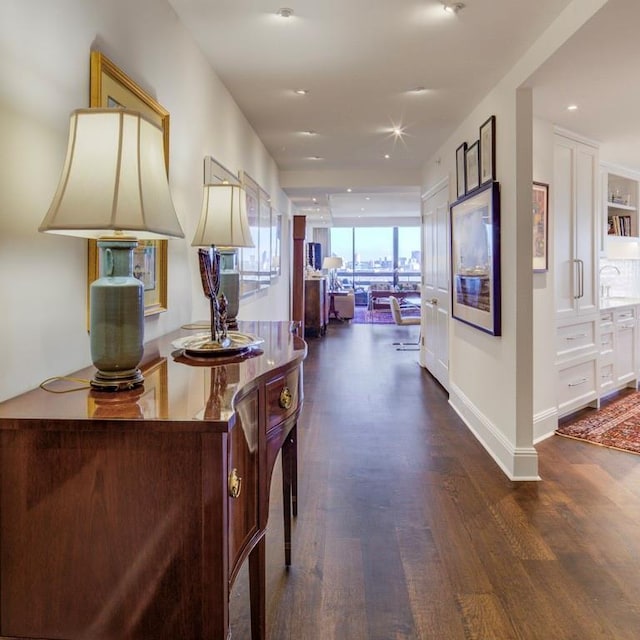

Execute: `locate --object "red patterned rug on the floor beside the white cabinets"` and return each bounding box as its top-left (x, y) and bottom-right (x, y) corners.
top-left (556, 393), bottom-right (640, 454)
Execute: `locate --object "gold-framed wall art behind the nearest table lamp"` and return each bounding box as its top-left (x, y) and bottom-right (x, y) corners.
top-left (87, 51), bottom-right (169, 316)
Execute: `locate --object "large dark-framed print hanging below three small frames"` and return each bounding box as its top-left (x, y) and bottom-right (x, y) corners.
top-left (450, 182), bottom-right (501, 336)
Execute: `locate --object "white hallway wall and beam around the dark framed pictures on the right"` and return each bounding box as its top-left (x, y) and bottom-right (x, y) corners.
top-left (422, 0), bottom-right (606, 480)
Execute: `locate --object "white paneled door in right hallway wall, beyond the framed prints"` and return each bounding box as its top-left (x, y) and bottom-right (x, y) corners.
top-left (420, 181), bottom-right (451, 391)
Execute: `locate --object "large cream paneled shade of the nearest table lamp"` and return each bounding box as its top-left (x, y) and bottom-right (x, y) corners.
top-left (39, 109), bottom-right (184, 240)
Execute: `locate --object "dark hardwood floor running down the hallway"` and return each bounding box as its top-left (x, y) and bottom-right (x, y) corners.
top-left (231, 324), bottom-right (640, 640)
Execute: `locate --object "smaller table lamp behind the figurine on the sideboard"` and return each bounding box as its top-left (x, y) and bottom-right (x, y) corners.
top-left (191, 180), bottom-right (254, 329)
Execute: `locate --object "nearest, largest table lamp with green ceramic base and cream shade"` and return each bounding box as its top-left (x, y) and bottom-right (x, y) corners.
top-left (38, 109), bottom-right (184, 391)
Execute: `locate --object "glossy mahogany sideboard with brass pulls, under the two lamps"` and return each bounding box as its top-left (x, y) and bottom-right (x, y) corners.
top-left (0, 322), bottom-right (306, 640)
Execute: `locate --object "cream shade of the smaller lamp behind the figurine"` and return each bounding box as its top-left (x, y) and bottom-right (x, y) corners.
top-left (191, 182), bottom-right (255, 247)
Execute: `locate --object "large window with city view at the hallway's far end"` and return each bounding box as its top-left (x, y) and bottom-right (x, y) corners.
top-left (330, 227), bottom-right (420, 304)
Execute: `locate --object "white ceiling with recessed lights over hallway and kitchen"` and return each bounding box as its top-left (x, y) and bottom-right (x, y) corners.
top-left (169, 0), bottom-right (640, 223)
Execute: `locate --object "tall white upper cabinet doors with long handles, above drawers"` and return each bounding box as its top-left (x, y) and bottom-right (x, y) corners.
top-left (553, 131), bottom-right (600, 322)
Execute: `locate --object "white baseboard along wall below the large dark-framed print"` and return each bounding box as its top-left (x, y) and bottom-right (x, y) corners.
top-left (449, 383), bottom-right (540, 482)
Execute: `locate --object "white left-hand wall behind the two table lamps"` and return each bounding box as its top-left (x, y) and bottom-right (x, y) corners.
top-left (0, 0), bottom-right (290, 400)
